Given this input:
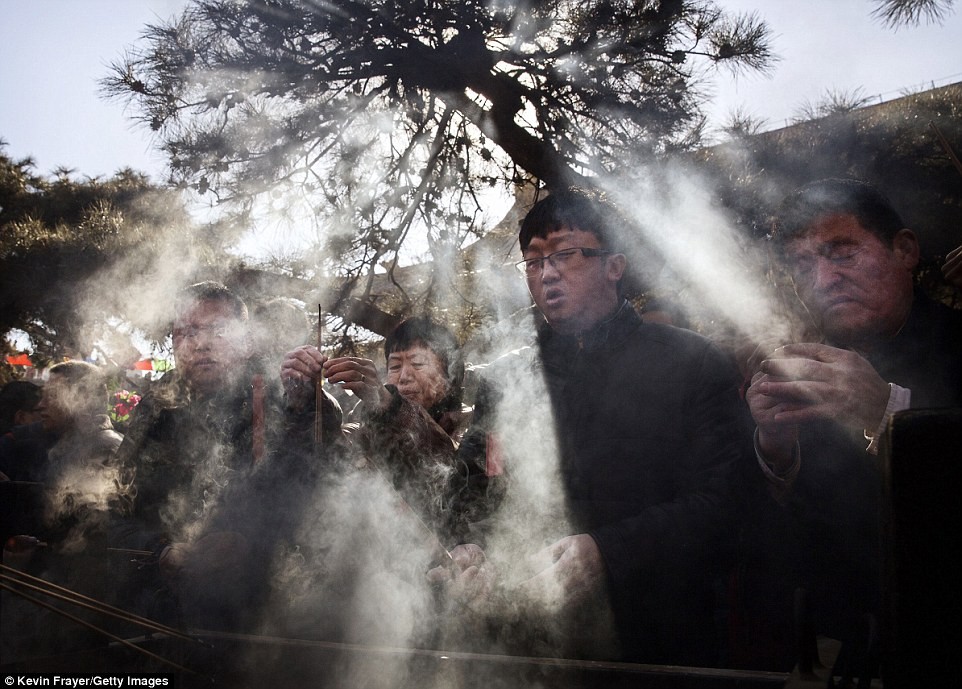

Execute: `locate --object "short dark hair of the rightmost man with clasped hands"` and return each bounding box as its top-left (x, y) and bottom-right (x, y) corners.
top-left (771, 178), bottom-right (905, 248)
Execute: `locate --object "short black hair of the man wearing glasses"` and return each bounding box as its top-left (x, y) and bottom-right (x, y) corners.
top-left (518, 187), bottom-right (627, 253)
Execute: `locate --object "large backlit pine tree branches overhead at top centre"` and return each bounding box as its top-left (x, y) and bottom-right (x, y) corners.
top-left (105, 0), bottom-right (773, 312)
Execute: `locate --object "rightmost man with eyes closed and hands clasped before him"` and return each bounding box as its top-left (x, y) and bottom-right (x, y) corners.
top-left (745, 179), bottom-right (962, 671)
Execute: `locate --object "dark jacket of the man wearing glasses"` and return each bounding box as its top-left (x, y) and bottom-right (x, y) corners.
top-left (461, 304), bottom-right (751, 665)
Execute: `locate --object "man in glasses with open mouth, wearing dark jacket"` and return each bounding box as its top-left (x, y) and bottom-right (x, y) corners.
top-left (433, 189), bottom-right (750, 665)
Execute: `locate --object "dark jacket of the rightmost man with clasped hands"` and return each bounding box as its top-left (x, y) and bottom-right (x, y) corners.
top-left (738, 294), bottom-right (962, 670)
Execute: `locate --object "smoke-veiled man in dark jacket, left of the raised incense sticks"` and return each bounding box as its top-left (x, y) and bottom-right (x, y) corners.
top-left (114, 282), bottom-right (341, 628)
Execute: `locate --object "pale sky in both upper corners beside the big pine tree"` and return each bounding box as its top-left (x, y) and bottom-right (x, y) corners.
top-left (0, 0), bottom-right (962, 181)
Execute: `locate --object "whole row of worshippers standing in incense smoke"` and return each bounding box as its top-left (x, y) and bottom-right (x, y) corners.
top-left (0, 180), bottom-right (962, 676)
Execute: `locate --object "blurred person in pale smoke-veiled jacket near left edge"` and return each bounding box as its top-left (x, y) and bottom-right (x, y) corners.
top-left (2, 361), bottom-right (122, 660)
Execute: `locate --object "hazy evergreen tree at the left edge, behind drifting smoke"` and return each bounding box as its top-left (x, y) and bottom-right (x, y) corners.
top-left (0, 142), bottom-right (202, 359)
